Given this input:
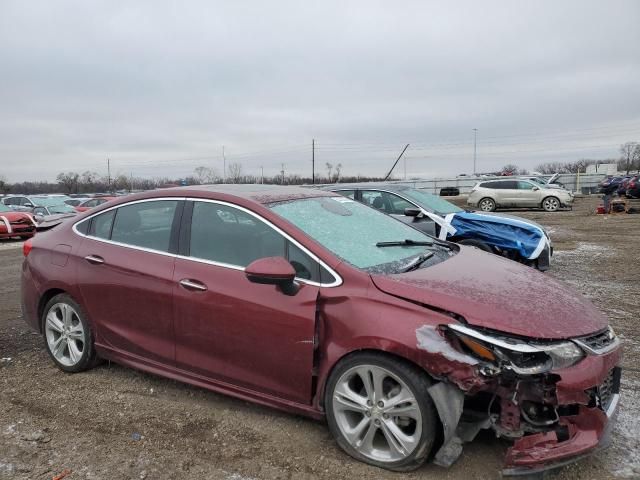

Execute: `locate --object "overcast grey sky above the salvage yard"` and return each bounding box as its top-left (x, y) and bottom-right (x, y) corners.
top-left (0, 0), bottom-right (640, 181)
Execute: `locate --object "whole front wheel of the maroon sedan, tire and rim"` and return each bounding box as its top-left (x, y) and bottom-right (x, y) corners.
top-left (325, 353), bottom-right (437, 472)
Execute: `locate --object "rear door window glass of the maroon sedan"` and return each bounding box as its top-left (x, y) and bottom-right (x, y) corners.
top-left (109, 200), bottom-right (178, 252)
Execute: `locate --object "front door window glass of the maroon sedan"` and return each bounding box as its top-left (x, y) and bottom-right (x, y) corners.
top-left (189, 202), bottom-right (285, 267)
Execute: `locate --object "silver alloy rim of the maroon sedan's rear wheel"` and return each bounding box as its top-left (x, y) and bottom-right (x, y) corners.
top-left (45, 303), bottom-right (86, 367)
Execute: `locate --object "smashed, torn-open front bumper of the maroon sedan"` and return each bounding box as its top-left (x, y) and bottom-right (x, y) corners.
top-left (418, 328), bottom-right (622, 475)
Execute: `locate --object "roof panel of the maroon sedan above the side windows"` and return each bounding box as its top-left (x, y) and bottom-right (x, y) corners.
top-left (121, 184), bottom-right (337, 204)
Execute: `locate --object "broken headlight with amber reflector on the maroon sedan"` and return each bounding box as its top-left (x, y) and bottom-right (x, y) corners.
top-left (449, 325), bottom-right (584, 375)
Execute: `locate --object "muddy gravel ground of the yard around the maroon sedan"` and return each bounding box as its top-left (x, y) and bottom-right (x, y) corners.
top-left (0, 197), bottom-right (640, 480)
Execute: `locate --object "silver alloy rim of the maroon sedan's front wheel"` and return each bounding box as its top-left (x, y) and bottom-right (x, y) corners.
top-left (332, 365), bottom-right (422, 463)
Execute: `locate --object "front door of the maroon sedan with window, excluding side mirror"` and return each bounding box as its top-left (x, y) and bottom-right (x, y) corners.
top-left (173, 200), bottom-right (320, 403)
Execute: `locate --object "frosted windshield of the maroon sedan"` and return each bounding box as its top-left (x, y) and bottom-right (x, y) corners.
top-left (270, 197), bottom-right (449, 273)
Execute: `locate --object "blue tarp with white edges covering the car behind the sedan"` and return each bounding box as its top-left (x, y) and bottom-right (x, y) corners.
top-left (447, 212), bottom-right (549, 260)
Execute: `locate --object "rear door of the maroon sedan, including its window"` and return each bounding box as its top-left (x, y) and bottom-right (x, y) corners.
top-left (76, 199), bottom-right (184, 365)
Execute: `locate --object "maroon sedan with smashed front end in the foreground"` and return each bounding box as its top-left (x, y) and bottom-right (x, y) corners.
top-left (22, 185), bottom-right (621, 474)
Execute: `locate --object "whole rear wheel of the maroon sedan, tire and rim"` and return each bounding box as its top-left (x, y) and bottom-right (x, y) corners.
top-left (42, 293), bottom-right (97, 373)
